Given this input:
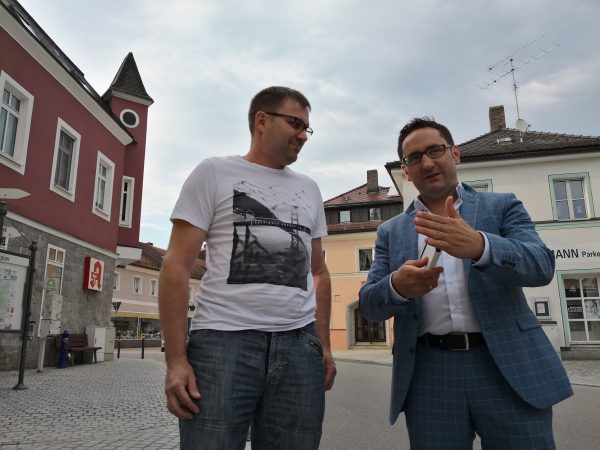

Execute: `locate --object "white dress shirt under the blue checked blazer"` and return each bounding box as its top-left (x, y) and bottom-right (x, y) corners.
top-left (390, 183), bottom-right (490, 336)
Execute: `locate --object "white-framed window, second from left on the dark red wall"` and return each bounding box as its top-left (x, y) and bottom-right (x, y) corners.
top-left (50, 119), bottom-right (81, 201)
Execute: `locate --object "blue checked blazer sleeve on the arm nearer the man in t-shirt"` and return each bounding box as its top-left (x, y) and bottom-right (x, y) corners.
top-left (359, 222), bottom-right (411, 322)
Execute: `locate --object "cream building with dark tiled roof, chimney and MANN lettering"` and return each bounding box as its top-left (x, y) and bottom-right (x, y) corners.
top-left (386, 106), bottom-right (600, 359)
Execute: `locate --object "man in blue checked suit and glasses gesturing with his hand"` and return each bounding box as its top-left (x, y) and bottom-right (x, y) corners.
top-left (360, 117), bottom-right (573, 450)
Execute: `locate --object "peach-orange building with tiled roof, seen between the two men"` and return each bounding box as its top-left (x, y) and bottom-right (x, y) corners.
top-left (322, 170), bottom-right (402, 349)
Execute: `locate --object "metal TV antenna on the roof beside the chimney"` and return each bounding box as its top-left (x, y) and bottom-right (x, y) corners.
top-left (480, 34), bottom-right (559, 134)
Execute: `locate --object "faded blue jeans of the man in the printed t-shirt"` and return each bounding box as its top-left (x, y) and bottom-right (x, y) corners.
top-left (179, 324), bottom-right (325, 450)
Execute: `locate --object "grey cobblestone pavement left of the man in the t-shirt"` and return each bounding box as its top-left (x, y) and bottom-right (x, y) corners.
top-left (0, 359), bottom-right (179, 450)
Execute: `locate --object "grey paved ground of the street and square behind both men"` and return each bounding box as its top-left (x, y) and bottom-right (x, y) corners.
top-left (0, 349), bottom-right (600, 450)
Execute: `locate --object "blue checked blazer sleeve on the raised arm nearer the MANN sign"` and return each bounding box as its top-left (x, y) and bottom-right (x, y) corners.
top-left (473, 194), bottom-right (555, 286)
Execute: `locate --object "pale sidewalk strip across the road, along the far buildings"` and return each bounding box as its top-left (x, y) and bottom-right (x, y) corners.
top-left (332, 349), bottom-right (600, 387)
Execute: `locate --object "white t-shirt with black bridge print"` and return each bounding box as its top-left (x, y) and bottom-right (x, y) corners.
top-left (171, 156), bottom-right (327, 331)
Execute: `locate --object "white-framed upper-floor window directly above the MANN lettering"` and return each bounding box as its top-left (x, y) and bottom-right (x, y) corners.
top-left (549, 173), bottom-right (595, 220)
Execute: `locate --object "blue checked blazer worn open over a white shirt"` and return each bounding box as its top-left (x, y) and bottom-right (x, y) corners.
top-left (360, 185), bottom-right (573, 424)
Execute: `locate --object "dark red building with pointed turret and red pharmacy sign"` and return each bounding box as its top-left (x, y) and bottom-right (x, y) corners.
top-left (0, 0), bottom-right (153, 370)
